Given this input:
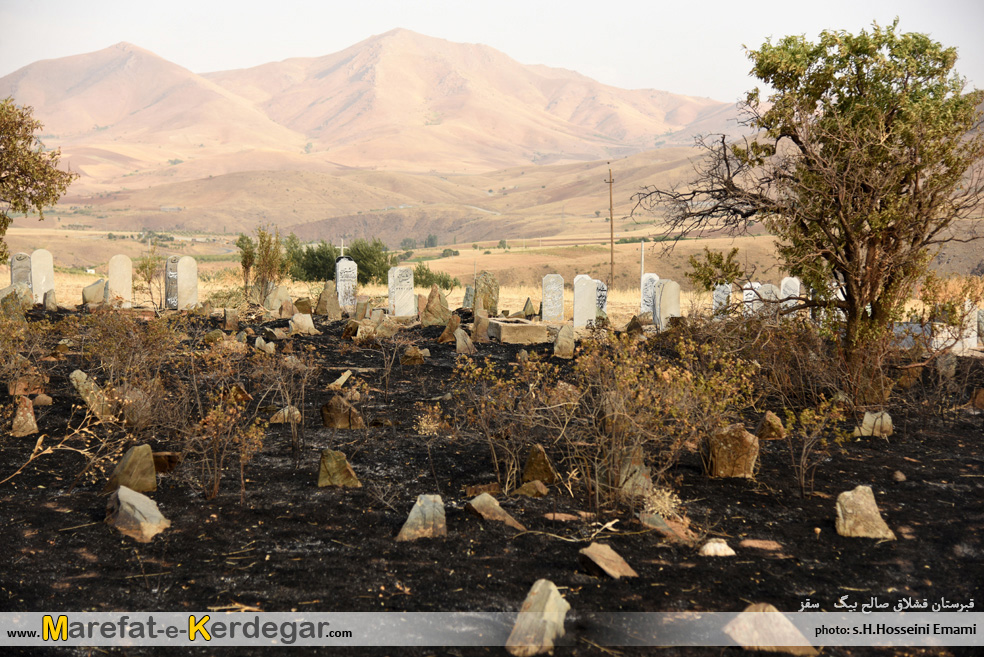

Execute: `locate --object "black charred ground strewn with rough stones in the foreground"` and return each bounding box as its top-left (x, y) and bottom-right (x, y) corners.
top-left (0, 308), bottom-right (984, 655)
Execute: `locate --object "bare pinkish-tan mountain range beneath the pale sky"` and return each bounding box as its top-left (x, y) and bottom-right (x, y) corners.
top-left (0, 29), bottom-right (736, 241)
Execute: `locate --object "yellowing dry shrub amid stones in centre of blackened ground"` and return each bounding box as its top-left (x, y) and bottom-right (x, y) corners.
top-left (457, 332), bottom-right (755, 506)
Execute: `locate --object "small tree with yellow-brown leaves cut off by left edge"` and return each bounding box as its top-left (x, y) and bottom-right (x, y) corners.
top-left (0, 97), bottom-right (78, 260)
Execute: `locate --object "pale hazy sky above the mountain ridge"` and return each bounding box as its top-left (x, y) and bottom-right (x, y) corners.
top-left (0, 0), bottom-right (984, 101)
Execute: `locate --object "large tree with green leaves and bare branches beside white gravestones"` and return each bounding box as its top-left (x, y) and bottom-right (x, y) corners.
top-left (636, 21), bottom-right (984, 358)
